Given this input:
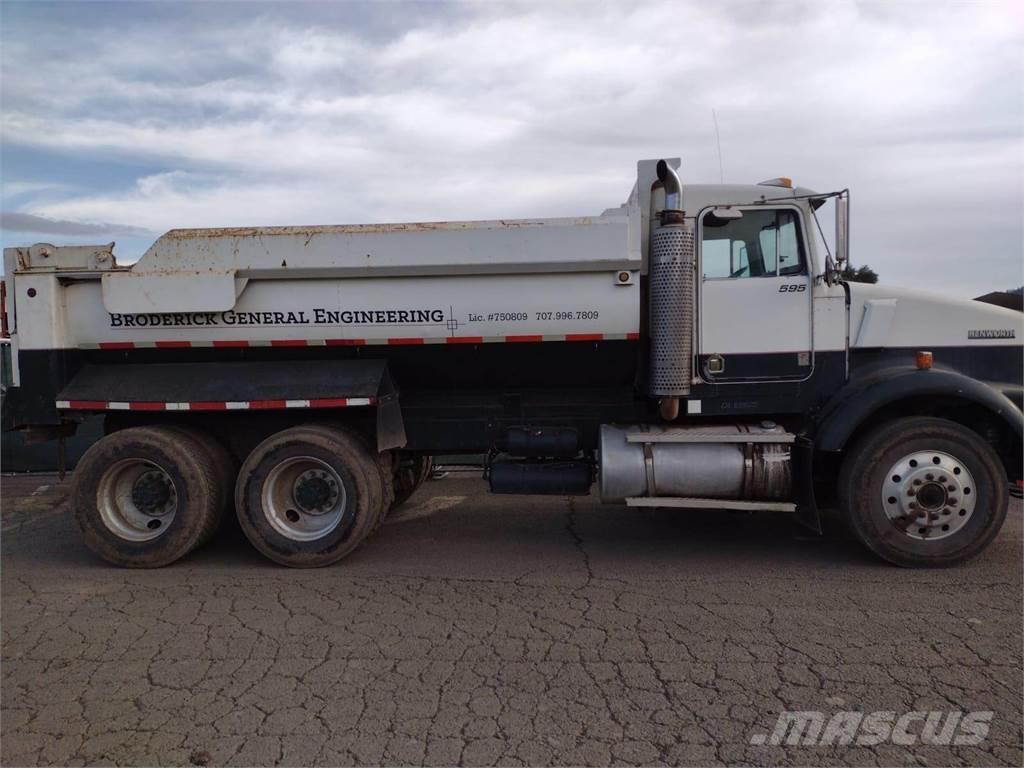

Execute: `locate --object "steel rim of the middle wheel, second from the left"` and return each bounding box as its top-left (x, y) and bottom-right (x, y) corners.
top-left (261, 456), bottom-right (348, 542)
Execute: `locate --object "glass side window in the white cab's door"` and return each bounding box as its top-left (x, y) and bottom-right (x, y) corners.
top-left (700, 209), bottom-right (806, 280)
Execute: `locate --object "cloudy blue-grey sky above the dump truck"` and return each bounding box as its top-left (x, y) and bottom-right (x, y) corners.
top-left (0, 0), bottom-right (1024, 296)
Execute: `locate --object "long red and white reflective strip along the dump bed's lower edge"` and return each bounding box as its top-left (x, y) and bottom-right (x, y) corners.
top-left (79, 333), bottom-right (640, 350)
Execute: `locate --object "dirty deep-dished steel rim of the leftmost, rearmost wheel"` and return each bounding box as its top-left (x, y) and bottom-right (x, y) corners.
top-left (96, 459), bottom-right (178, 542)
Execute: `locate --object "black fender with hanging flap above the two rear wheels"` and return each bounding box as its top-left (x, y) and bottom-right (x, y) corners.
top-left (57, 360), bottom-right (406, 451)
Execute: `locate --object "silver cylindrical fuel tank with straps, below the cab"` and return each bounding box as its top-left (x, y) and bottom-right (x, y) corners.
top-left (599, 424), bottom-right (792, 502)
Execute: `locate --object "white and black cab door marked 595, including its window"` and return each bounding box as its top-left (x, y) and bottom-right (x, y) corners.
top-left (697, 206), bottom-right (814, 382)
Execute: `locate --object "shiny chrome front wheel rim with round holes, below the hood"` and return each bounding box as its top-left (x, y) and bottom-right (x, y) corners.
top-left (882, 451), bottom-right (978, 542)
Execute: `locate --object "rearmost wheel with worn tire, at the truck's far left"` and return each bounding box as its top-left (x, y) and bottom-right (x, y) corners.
top-left (72, 426), bottom-right (224, 568)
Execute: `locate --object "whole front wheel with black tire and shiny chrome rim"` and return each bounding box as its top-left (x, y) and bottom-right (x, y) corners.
top-left (839, 417), bottom-right (1009, 567)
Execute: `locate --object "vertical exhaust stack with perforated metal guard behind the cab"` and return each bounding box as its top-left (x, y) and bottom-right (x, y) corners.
top-left (648, 160), bottom-right (695, 405)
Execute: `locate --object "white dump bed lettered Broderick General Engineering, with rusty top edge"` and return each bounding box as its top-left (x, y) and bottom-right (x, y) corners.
top-left (5, 210), bottom-right (640, 349)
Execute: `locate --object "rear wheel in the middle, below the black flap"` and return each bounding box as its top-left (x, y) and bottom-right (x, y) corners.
top-left (234, 425), bottom-right (384, 568)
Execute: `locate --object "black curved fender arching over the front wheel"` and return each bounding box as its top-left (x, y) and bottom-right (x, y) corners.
top-left (814, 366), bottom-right (1024, 451)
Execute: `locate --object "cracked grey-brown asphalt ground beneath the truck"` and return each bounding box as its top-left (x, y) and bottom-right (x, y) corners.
top-left (0, 476), bottom-right (1024, 766)
